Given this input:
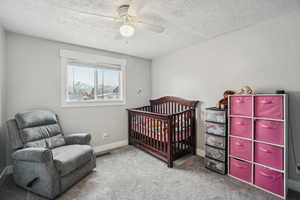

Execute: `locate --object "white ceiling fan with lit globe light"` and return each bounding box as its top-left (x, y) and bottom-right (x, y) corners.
top-left (58, 4), bottom-right (165, 38)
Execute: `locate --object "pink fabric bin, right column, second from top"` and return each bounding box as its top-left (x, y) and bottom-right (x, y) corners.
top-left (255, 120), bottom-right (284, 145)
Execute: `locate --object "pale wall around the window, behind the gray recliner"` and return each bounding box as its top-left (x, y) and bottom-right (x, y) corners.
top-left (6, 32), bottom-right (151, 150)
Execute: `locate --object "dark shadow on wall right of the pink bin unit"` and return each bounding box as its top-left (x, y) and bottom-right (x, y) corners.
top-left (288, 91), bottom-right (300, 181)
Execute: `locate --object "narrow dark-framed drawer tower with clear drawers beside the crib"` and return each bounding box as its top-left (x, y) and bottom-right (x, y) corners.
top-left (205, 107), bottom-right (227, 174)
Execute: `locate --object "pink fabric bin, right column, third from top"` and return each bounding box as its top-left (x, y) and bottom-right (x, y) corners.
top-left (255, 143), bottom-right (283, 170)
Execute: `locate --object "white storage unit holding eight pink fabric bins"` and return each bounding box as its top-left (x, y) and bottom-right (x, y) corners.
top-left (227, 94), bottom-right (288, 199)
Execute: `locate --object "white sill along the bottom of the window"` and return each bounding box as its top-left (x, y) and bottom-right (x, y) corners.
top-left (61, 100), bottom-right (126, 108)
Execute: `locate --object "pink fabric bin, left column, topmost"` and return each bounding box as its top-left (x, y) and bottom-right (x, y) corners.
top-left (230, 96), bottom-right (252, 116)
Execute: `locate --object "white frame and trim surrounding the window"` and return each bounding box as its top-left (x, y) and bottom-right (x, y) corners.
top-left (60, 49), bottom-right (127, 107)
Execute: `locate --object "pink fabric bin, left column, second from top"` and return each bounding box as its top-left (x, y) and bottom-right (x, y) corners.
top-left (230, 117), bottom-right (252, 138)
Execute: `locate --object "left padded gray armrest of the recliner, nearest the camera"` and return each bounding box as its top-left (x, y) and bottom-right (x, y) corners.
top-left (12, 147), bottom-right (53, 163)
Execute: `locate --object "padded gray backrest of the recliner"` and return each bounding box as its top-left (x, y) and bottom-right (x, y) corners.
top-left (15, 110), bottom-right (65, 149)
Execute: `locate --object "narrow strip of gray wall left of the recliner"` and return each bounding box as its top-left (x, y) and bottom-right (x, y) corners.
top-left (0, 24), bottom-right (6, 169)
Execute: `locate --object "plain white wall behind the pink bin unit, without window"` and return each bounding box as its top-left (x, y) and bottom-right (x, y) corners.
top-left (152, 12), bottom-right (300, 180)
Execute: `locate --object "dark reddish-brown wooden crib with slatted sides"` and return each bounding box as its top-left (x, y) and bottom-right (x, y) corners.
top-left (128, 96), bottom-right (198, 168)
